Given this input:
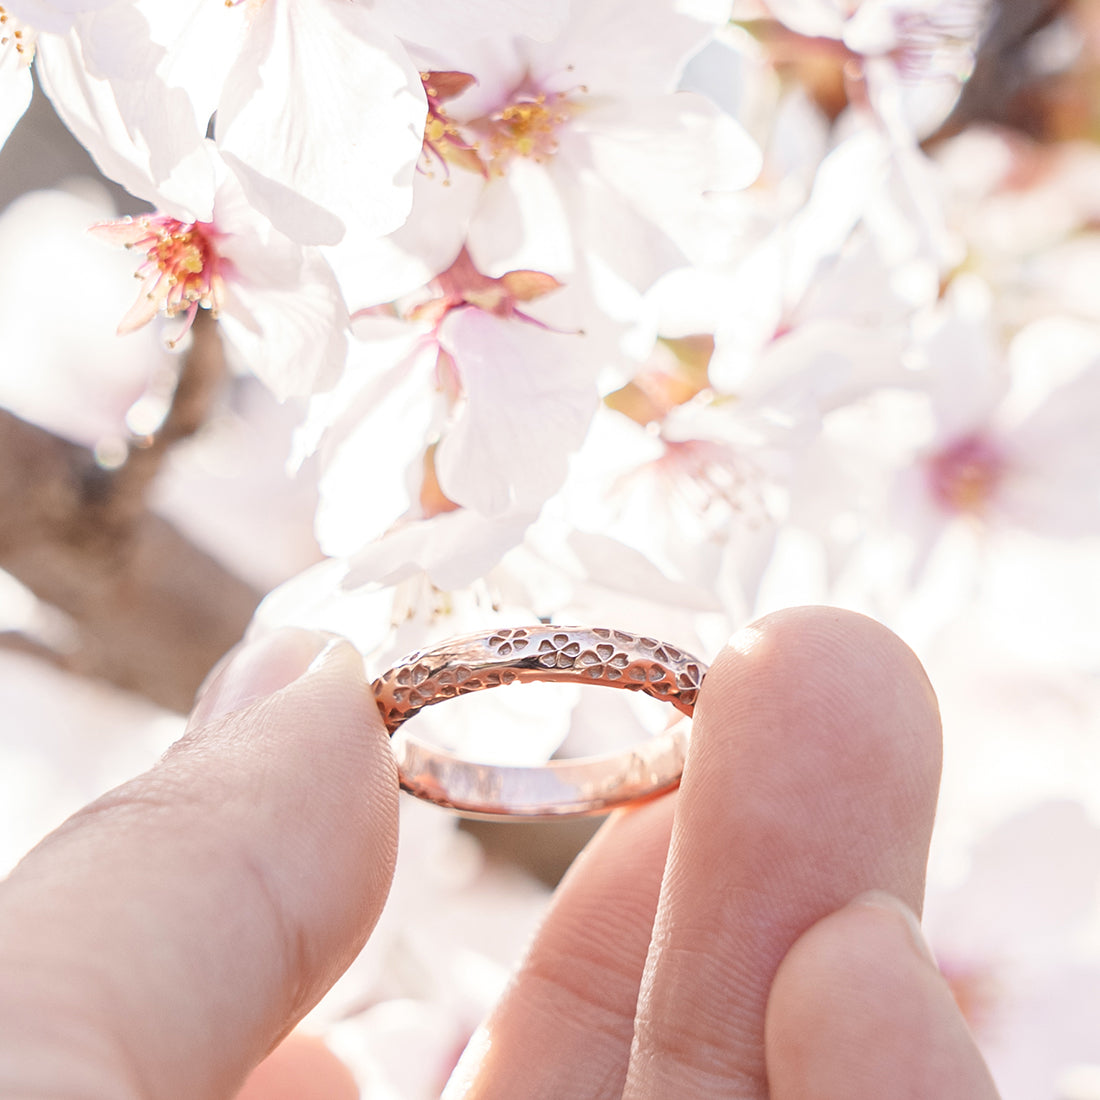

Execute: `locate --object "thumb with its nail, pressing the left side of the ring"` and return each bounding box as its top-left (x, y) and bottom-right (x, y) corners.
top-left (0, 630), bottom-right (397, 1100)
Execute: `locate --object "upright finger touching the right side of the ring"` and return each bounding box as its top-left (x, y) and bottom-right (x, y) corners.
top-left (624, 608), bottom-right (941, 1100)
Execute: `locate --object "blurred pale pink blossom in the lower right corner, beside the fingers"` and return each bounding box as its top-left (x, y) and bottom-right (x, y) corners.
top-left (925, 801), bottom-right (1100, 1100)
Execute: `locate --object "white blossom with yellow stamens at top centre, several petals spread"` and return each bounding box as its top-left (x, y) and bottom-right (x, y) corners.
top-left (347, 0), bottom-right (759, 305)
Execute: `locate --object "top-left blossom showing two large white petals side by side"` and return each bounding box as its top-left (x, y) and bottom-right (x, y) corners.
top-left (32, 0), bottom-right (425, 243)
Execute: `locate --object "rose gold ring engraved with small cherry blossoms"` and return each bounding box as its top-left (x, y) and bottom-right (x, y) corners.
top-left (372, 624), bottom-right (706, 821)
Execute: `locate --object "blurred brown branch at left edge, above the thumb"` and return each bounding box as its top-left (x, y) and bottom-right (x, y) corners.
top-left (0, 316), bottom-right (260, 711)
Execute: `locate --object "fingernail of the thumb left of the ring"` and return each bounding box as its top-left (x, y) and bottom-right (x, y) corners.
top-left (187, 627), bottom-right (342, 729)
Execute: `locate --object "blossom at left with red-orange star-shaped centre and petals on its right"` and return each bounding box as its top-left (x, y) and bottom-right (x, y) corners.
top-left (94, 144), bottom-right (348, 399)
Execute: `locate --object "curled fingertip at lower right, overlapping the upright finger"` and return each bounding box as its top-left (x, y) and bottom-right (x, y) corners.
top-left (766, 892), bottom-right (997, 1100)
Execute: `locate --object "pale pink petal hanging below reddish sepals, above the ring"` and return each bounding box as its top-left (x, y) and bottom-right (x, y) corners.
top-left (437, 309), bottom-right (597, 516)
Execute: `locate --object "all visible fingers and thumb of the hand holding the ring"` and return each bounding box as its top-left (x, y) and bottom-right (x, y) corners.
top-left (0, 608), bottom-right (997, 1100)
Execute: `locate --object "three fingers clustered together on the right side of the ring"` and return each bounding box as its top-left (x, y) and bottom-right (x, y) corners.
top-left (444, 608), bottom-right (997, 1100)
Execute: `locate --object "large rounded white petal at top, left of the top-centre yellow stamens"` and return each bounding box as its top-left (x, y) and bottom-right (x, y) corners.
top-left (216, 0), bottom-right (427, 244)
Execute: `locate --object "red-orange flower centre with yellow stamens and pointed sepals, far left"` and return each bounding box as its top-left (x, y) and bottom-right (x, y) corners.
top-left (91, 215), bottom-right (229, 344)
